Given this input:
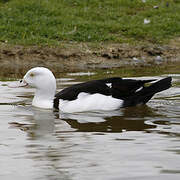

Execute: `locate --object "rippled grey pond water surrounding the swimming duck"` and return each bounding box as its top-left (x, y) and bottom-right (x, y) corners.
top-left (0, 73), bottom-right (180, 180)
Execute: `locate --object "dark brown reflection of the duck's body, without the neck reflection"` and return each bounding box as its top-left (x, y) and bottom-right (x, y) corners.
top-left (58, 106), bottom-right (156, 132)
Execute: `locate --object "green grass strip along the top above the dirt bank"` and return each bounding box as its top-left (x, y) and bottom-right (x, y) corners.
top-left (0, 0), bottom-right (180, 45)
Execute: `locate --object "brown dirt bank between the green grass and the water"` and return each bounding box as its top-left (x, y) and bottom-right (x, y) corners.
top-left (0, 41), bottom-right (180, 77)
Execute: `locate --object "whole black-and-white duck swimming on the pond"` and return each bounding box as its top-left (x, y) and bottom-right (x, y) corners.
top-left (9, 67), bottom-right (171, 113)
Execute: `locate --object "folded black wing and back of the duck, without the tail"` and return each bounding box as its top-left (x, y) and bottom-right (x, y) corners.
top-left (54, 77), bottom-right (154, 108)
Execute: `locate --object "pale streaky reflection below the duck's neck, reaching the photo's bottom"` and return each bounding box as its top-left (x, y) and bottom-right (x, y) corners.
top-left (22, 108), bottom-right (71, 180)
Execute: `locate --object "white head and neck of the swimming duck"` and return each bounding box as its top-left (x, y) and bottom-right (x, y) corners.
top-left (20, 67), bottom-right (56, 109)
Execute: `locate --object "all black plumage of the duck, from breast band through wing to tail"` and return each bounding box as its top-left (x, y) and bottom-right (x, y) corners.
top-left (54, 77), bottom-right (171, 109)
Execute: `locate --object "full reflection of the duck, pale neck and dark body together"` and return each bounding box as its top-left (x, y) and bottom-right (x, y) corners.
top-left (10, 105), bottom-right (158, 135)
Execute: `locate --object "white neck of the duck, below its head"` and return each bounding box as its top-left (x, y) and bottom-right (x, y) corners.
top-left (32, 87), bottom-right (55, 109)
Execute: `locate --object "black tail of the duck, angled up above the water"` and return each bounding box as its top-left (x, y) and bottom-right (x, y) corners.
top-left (123, 77), bottom-right (172, 107)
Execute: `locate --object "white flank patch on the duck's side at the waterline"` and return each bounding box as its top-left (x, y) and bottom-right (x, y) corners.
top-left (59, 93), bottom-right (123, 113)
